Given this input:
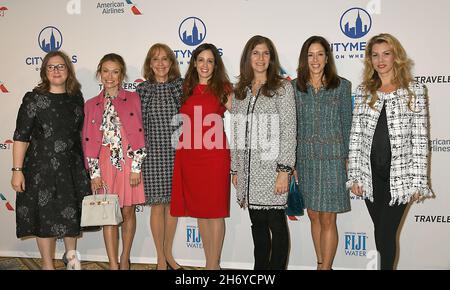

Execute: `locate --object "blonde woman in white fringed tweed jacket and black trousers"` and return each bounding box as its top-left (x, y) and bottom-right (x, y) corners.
top-left (347, 34), bottom-right (431, 269)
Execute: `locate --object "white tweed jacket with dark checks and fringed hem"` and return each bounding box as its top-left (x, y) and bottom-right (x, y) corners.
top-left (346, 81), bottom-right (432, 205)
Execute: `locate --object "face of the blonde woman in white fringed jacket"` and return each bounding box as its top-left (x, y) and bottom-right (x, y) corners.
top-left (370, 42), bottom-right (394, 76)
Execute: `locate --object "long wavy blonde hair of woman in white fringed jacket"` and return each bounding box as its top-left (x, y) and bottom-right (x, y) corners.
top-left (362, 33), bottom-right (414, 110)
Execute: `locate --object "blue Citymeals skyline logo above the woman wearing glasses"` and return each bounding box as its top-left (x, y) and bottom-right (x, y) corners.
top-left (25, 26), bottom-right (78, 71)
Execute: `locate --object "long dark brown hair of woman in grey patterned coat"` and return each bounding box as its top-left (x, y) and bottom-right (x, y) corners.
top-left (234, 35), bottom-right (283, 100)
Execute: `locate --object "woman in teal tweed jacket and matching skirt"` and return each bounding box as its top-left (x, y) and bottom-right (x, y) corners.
top-left (292, 36), bottom-right (352, 270)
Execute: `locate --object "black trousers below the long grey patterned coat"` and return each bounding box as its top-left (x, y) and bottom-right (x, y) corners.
top-left (249, 209), bottom-right (289, 270)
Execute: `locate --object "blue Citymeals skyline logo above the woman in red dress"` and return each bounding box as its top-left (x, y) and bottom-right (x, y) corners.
top-left (173, 16), bottom-right (223, 65)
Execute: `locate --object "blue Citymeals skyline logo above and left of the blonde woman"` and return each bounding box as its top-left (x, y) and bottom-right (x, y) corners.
top-left (330, 7), bottom-right (372, 60)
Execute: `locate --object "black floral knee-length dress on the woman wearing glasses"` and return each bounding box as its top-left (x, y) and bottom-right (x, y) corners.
top-left (14, 91), bottom-right (90, 238)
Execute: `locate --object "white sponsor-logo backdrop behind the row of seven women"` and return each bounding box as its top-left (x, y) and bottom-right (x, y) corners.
top-left (0, 0), bottom-right (450, 269)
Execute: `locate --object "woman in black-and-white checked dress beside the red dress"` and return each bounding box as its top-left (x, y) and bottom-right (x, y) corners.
top-left (136, 43), bottom-right (183, 270)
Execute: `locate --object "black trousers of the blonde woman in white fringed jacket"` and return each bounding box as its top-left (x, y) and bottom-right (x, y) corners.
top-left (366, 174), bottom-right (407, 270)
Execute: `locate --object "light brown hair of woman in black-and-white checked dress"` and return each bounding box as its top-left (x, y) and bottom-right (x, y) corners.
top-left (142, 43), bottom-right (181, 83)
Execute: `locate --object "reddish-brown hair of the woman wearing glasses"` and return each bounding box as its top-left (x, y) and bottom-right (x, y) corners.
top-left (34, 51), bottom-right (81, 96)
